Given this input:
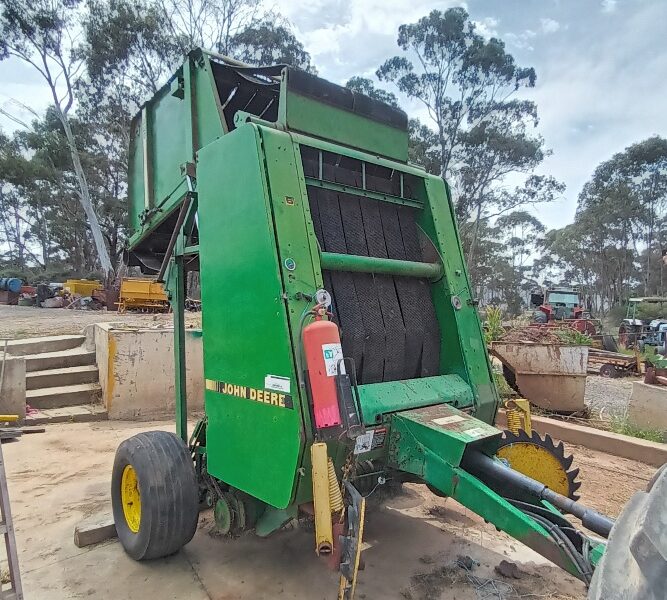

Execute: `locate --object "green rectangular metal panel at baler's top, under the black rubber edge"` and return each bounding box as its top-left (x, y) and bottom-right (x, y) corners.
top-left (281, 86), bottom-right (408, 162)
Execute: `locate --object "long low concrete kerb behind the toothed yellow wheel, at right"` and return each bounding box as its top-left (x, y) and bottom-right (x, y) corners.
top-left (496, 411), bottom-right (667, 467)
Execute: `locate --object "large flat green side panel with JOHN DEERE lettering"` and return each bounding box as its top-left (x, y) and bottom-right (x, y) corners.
top-left (197, 125), bottom-right (303, 508)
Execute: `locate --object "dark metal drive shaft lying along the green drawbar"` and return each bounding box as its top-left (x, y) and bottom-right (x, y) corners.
top-left (461, 451), bottom-right (614, 538)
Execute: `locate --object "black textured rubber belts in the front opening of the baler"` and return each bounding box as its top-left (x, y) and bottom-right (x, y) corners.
top-left (304, 161), bottom-right (440, 383)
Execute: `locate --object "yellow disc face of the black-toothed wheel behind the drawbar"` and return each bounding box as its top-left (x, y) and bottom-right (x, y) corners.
top-left (496, 442), bottom-right (570, 496)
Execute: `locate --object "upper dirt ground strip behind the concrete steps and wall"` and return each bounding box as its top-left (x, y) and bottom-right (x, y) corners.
top-left (0, 304), bottom-right (201, 339)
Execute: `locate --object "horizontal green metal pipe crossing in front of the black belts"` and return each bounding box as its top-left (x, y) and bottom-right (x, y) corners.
top-left (320, 252), bottom-right (442, 281)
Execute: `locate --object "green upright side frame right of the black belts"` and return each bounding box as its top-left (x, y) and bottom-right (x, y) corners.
top-left (419, 176), bottom-right (499, 423)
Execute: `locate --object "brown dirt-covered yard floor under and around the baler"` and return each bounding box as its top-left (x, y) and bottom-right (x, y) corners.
top-left (3, 422), bottom-right (654, 600)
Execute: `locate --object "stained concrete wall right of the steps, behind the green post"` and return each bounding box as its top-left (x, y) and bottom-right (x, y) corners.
top-left (94, 323), bottom-right (204, 420)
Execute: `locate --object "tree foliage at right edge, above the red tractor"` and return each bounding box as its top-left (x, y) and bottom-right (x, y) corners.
top-left (536, 136), bottom-right (667, 316)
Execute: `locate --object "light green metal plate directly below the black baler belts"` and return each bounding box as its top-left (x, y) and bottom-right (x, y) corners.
top-left (359, 375), bottom-right (473, 425)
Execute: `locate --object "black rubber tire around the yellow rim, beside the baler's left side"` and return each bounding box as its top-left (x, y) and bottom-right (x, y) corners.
top-left (111, 431), bottom-right (199, 560)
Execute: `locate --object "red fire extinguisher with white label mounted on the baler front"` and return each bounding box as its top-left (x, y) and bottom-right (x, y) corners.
top-left (303, 313), bottom-right (345, 429)
